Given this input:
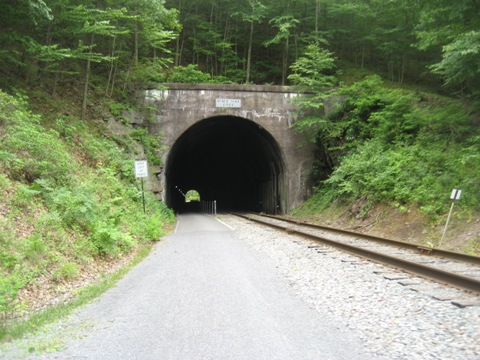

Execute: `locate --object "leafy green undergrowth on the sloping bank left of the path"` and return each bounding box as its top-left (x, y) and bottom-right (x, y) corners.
top-left (0, 91), bottom-right (173, 325)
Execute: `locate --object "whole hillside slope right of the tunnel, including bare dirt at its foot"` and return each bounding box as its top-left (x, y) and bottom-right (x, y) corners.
top-left (294, 75), bottom-right (480, 255)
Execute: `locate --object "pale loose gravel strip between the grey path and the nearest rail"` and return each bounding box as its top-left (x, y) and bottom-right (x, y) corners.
top-left (218, 215), bottom-right (480, 360)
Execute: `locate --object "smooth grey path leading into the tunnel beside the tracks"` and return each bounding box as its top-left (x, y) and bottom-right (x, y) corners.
top-left (0, 215), bottom-right (370, 360)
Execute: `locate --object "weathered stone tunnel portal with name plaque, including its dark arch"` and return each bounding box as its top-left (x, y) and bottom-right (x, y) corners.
top-left (135, 84), bottom-right (313, 213)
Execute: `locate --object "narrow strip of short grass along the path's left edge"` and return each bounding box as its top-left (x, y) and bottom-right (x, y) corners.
top-left (0, 243), bottom-right (152, 343)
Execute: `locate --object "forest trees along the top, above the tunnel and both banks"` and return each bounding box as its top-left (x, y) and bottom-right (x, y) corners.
top-left (0, 0), bottom-right (480, 95)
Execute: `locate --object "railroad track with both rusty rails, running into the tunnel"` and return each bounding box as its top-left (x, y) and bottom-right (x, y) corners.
top-left (233, 213), bottom-right (480, 306)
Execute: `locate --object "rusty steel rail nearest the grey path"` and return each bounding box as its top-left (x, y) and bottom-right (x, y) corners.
top-left (233, 213), bottom-right (480, 295)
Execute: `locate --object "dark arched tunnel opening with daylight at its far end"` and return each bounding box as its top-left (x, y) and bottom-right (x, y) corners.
top-left (165, 116), bottom-right (286, 214)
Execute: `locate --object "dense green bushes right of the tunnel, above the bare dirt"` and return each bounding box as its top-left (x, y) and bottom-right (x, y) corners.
top-left (290, 76), bottom-right (480, 228)
